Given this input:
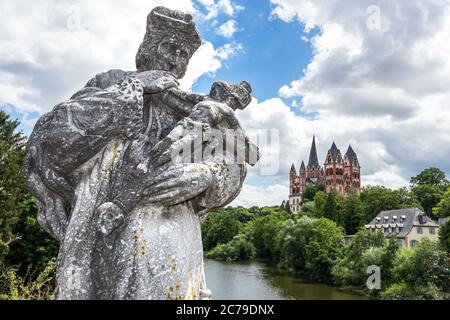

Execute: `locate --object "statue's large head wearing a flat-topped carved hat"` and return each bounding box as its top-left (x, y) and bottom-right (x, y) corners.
top-left (136, 7), bottom-right (201, 79)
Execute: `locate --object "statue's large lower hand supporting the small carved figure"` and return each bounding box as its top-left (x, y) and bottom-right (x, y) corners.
top-left (144, 163), bottom-right (213, 206)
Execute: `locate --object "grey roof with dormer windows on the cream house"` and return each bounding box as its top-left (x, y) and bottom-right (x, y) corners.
top-left (366, 208), bottom-right (439, 238)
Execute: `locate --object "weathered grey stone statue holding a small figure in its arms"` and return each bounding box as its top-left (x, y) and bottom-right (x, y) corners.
top-left (25, 7), bottom-right (259, 299)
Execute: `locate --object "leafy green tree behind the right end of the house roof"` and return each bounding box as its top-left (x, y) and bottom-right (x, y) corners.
top-left (410, 168), bottom-right (450, 217)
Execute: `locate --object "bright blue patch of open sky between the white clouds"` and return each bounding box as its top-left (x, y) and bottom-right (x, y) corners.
top-left (193, 1), bottom-right (312, 100)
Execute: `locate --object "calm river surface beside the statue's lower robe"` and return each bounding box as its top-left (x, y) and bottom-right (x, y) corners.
top-left (205, 259), bottom-right (366, 300)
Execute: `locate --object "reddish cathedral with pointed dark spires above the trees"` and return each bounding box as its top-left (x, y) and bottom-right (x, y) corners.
top-left (289, 136), bottom-right (361, 213)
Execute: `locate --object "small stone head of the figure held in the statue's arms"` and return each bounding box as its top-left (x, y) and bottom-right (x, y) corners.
top-left (209, 81), bottom-right (252, 110)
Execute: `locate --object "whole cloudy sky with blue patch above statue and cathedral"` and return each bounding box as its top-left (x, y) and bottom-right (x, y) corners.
top-left (0, 0), bottom-right (450, 206)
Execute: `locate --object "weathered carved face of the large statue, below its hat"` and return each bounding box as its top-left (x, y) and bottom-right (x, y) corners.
top-left (154, 36), bottom-right (191, 78)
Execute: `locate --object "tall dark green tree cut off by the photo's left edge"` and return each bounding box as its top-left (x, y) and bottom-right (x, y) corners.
top-left (0, 111), bottom-right (26, 263)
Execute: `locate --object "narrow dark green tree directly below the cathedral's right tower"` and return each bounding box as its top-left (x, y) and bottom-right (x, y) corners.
top-left (342, 188), bottom-right (363, 235)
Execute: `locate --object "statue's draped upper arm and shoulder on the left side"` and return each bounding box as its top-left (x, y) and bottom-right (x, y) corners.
top-left (41, 78), bottom-right (143, 171)
